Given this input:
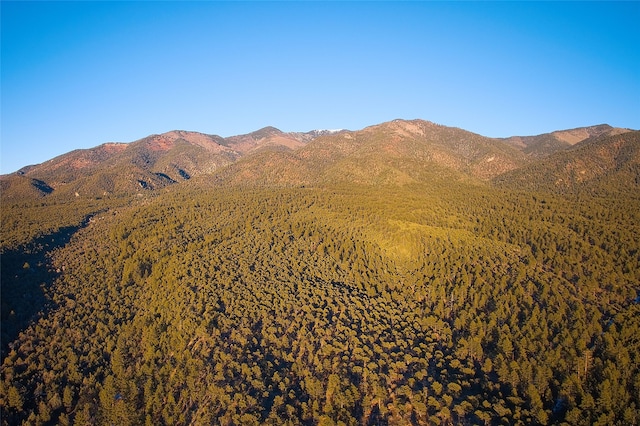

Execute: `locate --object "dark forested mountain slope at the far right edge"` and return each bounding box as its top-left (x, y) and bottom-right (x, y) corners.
top-left (495, 131), bottom-right (640, 196)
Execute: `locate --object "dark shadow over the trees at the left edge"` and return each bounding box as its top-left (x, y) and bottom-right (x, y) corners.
top-left (0, 215), bottom-right (92, 359)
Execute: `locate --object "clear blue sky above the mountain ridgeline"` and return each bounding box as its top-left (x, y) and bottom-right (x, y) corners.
top-left (0, 1), bottom-right (640, 173)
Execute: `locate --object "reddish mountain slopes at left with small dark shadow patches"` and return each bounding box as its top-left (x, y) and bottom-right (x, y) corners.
top-left (0, 128), bottom-right (313, 199)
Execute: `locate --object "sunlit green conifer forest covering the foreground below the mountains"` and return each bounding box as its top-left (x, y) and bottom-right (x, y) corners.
top-left (0, 179), bottom-right (640, 425)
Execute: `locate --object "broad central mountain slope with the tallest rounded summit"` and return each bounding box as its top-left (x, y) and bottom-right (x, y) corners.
top-left (216, 120), bottom-right (526, 185)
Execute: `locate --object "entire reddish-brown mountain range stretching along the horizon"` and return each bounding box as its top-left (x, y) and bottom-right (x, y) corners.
top-left (0, 120), bottom-right (640, 200)
